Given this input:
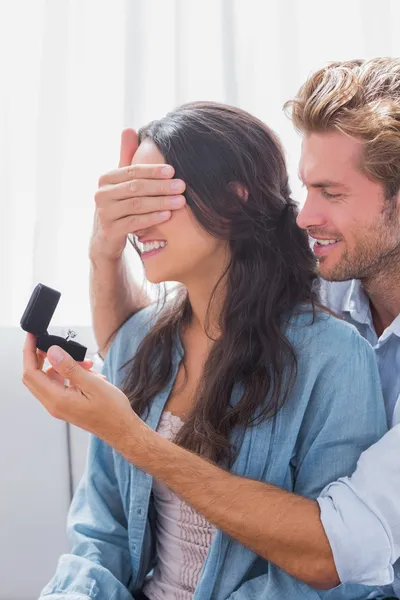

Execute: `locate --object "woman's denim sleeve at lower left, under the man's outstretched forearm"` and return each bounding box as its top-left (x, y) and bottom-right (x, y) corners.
top-left (40, 437), bottom-right (132, 600)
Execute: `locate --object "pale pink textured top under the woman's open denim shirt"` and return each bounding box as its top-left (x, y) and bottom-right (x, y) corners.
top-left (143, 411), bottom-right (215, 600)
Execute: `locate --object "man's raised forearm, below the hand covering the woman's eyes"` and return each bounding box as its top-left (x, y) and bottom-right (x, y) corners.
top-left (90, 255), bottom-right (148, 358)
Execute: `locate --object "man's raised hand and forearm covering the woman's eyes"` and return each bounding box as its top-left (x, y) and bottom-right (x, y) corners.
top-left (89, 129), bottom-right (185, 358)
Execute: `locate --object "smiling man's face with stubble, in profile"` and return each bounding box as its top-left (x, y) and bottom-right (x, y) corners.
top-left (297, 132), bottom-right (400, 281)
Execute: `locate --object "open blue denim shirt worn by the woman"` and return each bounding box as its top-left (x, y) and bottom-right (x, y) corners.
top-left (41, 307), bottom-right (386, 600)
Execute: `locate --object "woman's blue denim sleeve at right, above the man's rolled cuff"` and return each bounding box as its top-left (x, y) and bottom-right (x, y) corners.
top-left (292, 328), bottom-right (387, 498)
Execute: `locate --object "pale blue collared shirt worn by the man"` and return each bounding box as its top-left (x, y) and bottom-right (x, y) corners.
top-left (318, 280), bottom-right (400, 598)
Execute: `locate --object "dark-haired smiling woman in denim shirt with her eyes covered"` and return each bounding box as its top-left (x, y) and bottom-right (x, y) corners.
top-left (26, 103), bottom-right (385, 600)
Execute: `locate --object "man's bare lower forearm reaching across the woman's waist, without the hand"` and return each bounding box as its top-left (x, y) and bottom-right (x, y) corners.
top-left (124, 426), bottom-right (339, 589)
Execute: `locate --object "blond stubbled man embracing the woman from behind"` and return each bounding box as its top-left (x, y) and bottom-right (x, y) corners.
top-left (90, 59), bottom-right (400, 597)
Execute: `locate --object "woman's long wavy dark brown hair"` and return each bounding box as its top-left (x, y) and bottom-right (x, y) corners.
top-left (111, 102), bottom-right (318, 465)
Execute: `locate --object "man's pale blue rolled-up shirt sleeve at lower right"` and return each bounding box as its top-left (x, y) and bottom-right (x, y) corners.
top-left (318, 425), bottom-right (400, 585)
